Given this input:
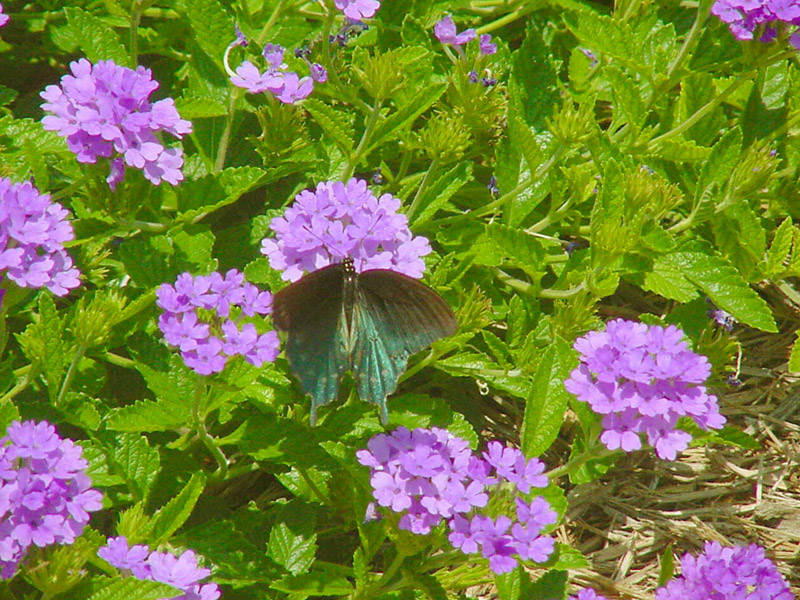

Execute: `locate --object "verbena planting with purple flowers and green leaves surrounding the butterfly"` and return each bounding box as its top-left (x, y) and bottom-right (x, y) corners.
top-left (0, 0), bottom-right (800, 600)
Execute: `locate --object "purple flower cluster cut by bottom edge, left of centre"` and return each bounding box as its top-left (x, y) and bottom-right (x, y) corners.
top-left (97, 537), bottom-right (220, 600)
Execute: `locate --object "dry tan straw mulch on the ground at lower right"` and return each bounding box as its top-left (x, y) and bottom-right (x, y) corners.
top-left (558, 326), bottom-right (800, 600)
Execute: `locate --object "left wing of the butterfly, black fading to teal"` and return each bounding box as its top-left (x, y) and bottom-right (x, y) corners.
top-left (272, 264), bottom-right (349, 425)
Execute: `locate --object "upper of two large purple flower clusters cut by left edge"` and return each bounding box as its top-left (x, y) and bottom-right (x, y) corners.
top-left (0, 177), bottom-right (80, 296)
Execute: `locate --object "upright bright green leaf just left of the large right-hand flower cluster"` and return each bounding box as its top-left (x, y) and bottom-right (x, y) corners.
top-left (522, 337), bottom-right (576, 456)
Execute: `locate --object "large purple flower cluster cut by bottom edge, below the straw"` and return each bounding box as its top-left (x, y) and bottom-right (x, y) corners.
top-left (656, 542), bottom-right (794, 600)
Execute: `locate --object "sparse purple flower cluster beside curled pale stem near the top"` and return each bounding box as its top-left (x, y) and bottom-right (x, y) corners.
top-left (231, 44), bottom-right (328, 104)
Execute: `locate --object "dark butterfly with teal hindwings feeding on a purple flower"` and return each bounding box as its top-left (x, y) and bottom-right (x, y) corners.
top-left (272, 257), bottom-right (458, 425)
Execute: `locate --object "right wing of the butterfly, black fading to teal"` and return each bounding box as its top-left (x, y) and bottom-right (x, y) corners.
top-left (350, 269), bottom-right (458, 424)
